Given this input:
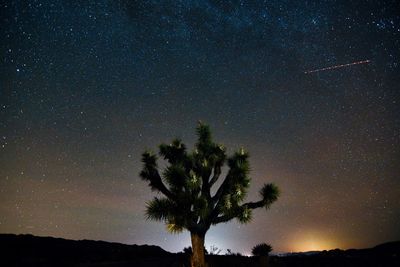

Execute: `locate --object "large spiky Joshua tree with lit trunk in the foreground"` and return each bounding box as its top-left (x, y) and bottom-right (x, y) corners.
top-left (140, 122), bottom-right (279, 267)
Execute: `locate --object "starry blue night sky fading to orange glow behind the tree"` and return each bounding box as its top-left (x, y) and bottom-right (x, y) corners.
top-left (0, 0), bottom-right (400, 253)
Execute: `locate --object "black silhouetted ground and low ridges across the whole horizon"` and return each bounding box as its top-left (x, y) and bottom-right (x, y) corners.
top-left (0, 234), bottom-right (400, 267)
